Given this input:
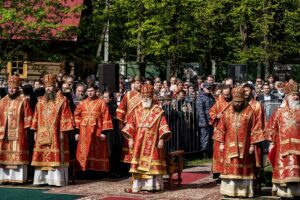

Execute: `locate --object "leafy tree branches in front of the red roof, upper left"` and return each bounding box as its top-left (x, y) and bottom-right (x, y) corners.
top-left (0, 0), bottom-right (81, 65)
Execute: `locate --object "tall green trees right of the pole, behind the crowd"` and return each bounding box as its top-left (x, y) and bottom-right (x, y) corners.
top-left (93, 0), bottom-right (300, 77)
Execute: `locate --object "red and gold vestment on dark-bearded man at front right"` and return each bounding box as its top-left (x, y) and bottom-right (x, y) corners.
top-left (214, 104), bottom-right (264, 179)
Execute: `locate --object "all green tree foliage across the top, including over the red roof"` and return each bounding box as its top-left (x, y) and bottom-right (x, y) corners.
top-left (0, 0), bottom-right (300, 78)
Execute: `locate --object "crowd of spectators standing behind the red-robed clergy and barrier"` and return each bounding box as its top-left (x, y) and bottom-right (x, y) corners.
top-left (0, 72), bottom-right (294, 153)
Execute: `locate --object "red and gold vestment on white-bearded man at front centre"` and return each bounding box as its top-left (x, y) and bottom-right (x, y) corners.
top-left (122, 105), bottom-right (171, 175)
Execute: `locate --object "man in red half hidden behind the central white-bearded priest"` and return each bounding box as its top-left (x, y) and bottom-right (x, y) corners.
top-left (116, 76), bottom-right (142, 163)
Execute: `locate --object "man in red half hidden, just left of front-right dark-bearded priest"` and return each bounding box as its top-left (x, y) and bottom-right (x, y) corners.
top-left (209, 85), bottom-right (232, 178)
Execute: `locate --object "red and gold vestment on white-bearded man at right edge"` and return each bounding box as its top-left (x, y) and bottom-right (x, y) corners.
top-left (266, 104), bottom-right (300, 184)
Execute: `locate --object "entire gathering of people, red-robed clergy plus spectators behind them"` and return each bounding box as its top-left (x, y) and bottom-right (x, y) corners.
top-left (0, 72), bottom-right (300, 197)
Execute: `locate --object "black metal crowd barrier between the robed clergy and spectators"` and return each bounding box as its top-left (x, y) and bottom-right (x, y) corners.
top-left (160, 99), bottom-right (281, 153)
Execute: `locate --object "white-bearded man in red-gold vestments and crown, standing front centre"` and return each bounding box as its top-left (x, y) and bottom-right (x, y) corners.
top-left (123, 84), bottom-right (171, 193)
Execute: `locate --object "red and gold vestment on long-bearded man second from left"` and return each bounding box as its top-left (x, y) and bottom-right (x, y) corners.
top-left (31, 92), bottom-right (74, 170)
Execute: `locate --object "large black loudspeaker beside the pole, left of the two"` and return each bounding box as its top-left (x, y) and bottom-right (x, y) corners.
top-left (97, 64), bottom-right (119, 92)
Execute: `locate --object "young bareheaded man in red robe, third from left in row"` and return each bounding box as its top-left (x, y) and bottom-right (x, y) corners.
top-left (74, 85), bottom-right (113, 171)
